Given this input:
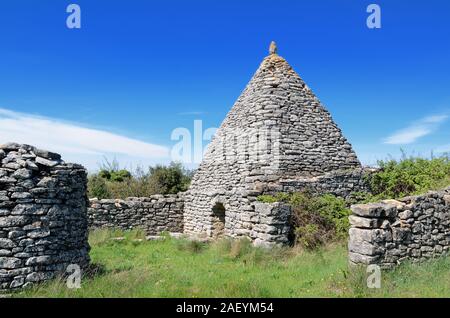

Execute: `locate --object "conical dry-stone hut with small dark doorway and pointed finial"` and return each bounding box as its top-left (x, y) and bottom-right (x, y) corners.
top-left (184, 43), bottom-right (365, 244)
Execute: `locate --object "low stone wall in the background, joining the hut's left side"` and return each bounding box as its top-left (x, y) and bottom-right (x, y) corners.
top-left (88, 194), bottom-right (184, 235)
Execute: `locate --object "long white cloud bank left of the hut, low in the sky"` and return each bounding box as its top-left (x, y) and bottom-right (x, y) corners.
top-left (0, 108), bottom-right (169, 169)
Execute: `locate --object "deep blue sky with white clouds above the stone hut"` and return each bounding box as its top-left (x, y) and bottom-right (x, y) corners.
top-left (0, 0), bottom-right (450, 169)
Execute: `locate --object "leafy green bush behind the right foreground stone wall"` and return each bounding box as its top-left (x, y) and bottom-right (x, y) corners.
top-left (370, 155), bottom-right (450, 199)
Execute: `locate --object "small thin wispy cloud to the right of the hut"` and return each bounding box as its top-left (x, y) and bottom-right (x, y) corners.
top-left (384, 115), bottom-right (449, 145)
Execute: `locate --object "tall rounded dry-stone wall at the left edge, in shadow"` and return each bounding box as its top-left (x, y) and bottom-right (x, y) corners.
top-left (0, 143), bottom-right (89, 290)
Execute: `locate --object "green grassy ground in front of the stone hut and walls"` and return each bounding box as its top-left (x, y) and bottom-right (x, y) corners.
top-left (13, 230), bottom-right (450, 297)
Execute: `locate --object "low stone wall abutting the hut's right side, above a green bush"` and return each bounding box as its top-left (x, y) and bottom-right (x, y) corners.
top-left (266, 168), bottom-right (376, 198)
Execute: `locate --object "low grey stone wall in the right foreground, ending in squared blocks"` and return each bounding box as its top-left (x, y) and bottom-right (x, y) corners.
top-left (349, 188), bottom-right (450, 268)
